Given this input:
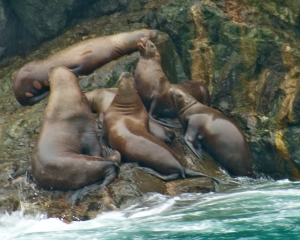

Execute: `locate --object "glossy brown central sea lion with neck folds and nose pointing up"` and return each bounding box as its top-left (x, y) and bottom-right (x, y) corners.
top-left (103, 72), bottom-right (218, 181)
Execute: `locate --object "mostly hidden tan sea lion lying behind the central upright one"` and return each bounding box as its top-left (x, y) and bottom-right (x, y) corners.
top-left (85, 88), bottom-right (176, 142)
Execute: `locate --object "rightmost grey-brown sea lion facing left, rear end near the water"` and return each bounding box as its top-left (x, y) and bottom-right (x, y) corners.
top-left (169, 88), bottom-right (253, 176)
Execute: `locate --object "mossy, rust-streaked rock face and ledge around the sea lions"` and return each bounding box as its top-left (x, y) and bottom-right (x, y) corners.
top-left (0, 0), bottom-right (300, 222)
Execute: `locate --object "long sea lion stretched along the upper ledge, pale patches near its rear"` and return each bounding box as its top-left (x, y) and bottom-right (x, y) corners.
top-left (14, 29), bottom-right (158, 105)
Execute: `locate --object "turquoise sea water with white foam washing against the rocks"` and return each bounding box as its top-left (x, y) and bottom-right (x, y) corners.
top-left (0, 179), bottom-right (300, 240)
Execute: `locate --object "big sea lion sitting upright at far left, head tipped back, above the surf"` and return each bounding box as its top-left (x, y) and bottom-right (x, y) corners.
top-left (31, 67), bottom-right (121, 202)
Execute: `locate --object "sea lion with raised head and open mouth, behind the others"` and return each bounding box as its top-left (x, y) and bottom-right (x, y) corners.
top-left (134, 38), bottom-right (211, 127)
